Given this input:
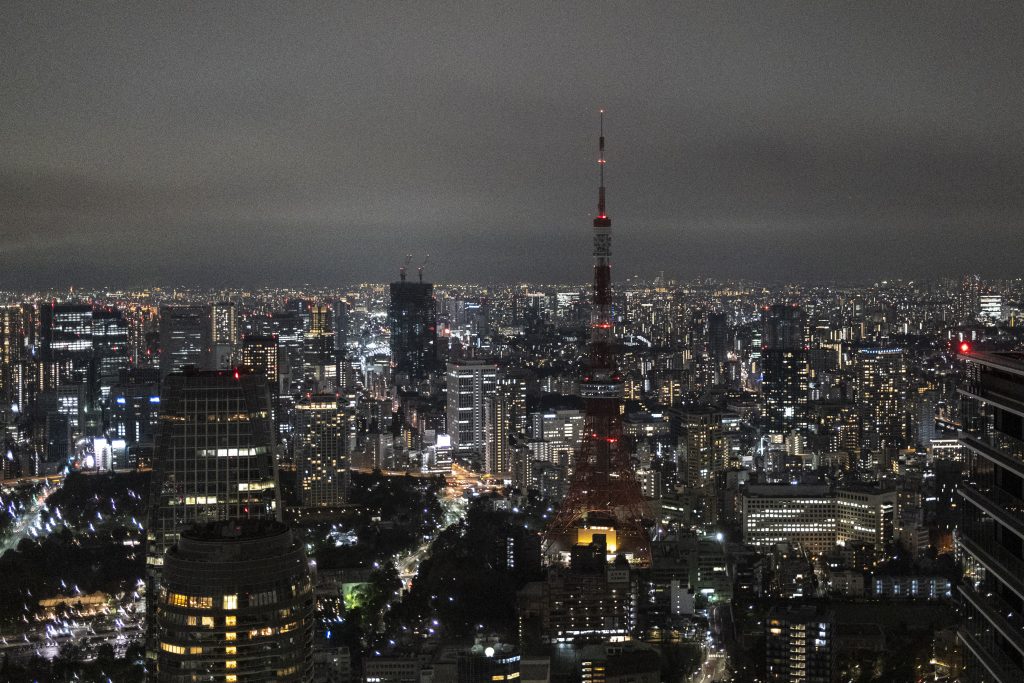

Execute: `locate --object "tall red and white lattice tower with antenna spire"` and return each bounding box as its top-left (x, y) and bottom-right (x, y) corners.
top-left (545, 111), bottom-right (650, 564)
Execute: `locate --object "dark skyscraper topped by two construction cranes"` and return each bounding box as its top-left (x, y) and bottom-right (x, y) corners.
top-left (388, 268), bottom-right (437, 387)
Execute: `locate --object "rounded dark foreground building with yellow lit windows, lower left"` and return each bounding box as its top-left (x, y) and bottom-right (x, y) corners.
top-left (154, 519), bottom-right (315, 683)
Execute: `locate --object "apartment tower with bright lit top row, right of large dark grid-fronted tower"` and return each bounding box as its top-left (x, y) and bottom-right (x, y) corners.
top-left (294, 393), bottom-right (356, 508)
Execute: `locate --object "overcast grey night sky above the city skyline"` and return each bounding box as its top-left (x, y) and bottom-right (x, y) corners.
top-left (0, 2), bottom-right (1024, 289)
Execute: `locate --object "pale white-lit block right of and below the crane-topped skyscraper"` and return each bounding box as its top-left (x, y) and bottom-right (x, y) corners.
top-left (447, 360), bottom-right (498, 456)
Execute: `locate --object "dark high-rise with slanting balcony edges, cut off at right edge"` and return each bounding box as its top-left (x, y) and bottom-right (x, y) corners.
top-left (958, 350), bottom-right (1024, 683)
